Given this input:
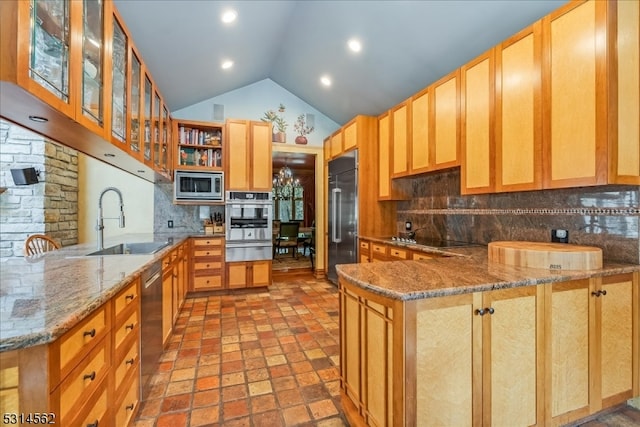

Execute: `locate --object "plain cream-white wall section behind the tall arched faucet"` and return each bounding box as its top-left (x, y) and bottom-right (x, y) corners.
top-left (78, 153), bottom-right (153, 243)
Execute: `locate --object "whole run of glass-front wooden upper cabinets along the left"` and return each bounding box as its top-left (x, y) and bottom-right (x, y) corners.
top-left (0, 0), bottom-right (168, 181)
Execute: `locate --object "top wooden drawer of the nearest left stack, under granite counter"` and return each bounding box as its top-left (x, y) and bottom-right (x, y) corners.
top-left (54, 303), bottom-right (110, 379)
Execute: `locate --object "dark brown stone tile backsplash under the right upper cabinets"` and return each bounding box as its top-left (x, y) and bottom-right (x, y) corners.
top-left (397, 169), bottom-right (640, 264)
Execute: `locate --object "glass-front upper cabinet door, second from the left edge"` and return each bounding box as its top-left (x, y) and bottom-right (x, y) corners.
top-left (78, 0), bottom-right (104, 132)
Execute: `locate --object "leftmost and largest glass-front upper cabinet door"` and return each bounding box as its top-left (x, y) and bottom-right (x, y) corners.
top-left (26, 0), bottom-right (78, 117)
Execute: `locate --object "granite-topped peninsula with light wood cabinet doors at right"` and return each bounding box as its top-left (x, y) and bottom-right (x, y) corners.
top-left (337, 246), bottom-right (640, 426)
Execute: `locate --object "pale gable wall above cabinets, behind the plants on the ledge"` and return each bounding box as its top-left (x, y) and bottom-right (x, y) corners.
top-left (171, 79), bottom-right (340, 150)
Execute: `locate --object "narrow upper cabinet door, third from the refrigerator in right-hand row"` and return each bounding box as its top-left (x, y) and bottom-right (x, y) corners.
top-left (409, 88), bottom-right (431, 175)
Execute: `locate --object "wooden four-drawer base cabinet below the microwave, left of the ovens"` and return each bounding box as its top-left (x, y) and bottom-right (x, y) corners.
top-left (189, 237), bottom-right (224, 292)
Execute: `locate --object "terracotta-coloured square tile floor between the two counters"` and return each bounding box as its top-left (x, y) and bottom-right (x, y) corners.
top-left (134, 274), bottom-right (347, 427)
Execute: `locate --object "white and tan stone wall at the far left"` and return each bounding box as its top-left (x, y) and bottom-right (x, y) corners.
top-left (0, 120), bottom-right (78, 258)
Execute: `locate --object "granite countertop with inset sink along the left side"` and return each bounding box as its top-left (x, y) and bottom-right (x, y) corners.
top-left (0, 233), bottom-right (216, 352)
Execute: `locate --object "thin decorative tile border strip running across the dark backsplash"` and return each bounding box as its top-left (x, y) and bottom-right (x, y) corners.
top-left (397, 207), bottom-right (640, 217)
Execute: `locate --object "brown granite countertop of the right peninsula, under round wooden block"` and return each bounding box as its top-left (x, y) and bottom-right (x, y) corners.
top-left (336, 237), bottom-right (640, 301)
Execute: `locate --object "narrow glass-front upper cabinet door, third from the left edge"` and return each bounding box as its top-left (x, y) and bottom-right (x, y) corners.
top-left (111, 12), bottom-right (129, 146)
